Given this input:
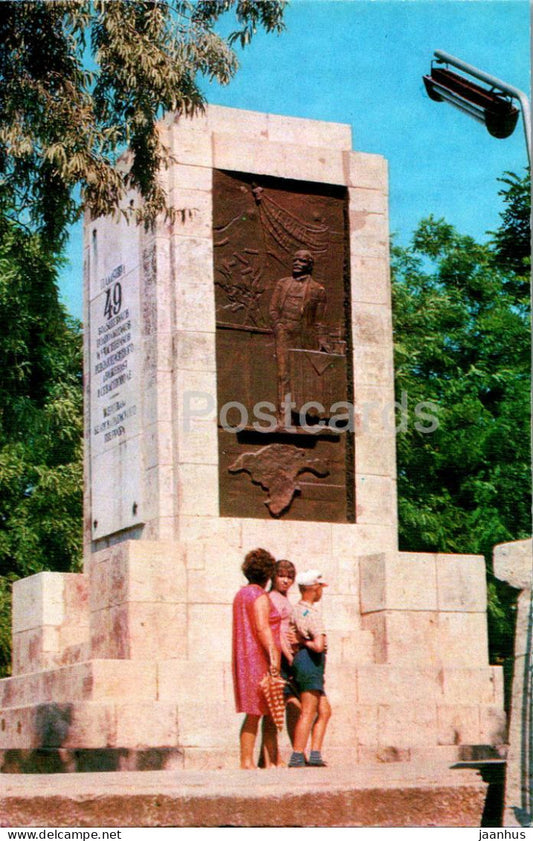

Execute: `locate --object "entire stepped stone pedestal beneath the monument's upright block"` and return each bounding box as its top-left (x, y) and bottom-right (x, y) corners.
top-left (0, 540), bottom-right (505, 772)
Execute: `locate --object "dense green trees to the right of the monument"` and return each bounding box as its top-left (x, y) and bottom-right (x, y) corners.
top-left (392, 174), bottom-right (531, 684)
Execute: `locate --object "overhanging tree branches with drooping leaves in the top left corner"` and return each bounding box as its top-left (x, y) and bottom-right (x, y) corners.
top-left (0, 0), bottom-right (285, 249)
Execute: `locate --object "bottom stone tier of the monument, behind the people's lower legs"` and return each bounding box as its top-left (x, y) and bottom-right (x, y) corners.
top-left (0, 701), bottom-right (505, 756)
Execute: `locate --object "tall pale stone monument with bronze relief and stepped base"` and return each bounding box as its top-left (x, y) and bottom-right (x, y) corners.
top-left (0, 106), bottom-right (505, 771)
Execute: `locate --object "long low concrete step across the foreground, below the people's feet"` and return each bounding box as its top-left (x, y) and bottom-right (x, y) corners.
top-left (0, 762), bottom-right (488, 827)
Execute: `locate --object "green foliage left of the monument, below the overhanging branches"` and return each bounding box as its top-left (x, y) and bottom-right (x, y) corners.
top-left (0, 217), bottom-right (83, 670)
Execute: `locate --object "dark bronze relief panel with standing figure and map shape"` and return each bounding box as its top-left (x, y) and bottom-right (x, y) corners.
top-left (213, 171), bottom-right (354, 522)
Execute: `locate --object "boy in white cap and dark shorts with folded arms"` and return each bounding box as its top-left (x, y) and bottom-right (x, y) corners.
top-left (289, 569), bottom-right (331, 768)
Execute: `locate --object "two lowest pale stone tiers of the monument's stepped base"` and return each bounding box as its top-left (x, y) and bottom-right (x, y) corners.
top-left (0, 659), bottom-right (505, 770)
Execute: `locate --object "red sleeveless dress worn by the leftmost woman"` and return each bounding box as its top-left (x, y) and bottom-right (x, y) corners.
top-left (232, 584), bottom-right (281, 715)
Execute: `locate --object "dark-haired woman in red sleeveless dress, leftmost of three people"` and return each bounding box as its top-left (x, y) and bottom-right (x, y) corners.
top-left (233, 549), bottom-right (281, 768)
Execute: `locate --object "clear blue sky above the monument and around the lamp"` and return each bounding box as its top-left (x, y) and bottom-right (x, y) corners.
top-left (61, 0), bottom-right (530, 318)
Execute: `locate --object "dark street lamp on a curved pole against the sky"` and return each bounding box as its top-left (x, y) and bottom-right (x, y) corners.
top-left (423, 50), bottom-right (531, 164)
